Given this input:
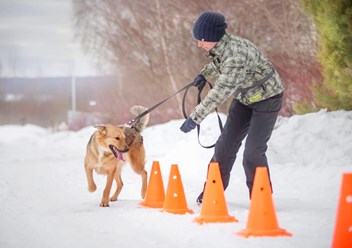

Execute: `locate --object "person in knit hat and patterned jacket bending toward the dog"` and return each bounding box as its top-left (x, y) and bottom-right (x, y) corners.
top-left (180, 12), bottom-right (284, 204)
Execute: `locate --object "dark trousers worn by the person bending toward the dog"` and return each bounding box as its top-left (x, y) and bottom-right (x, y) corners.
top-left (205, 94), bottom-right (282, 196)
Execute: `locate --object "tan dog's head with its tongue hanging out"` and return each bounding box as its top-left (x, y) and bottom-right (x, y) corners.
top-left (95, 125), bottom-right (129, 160)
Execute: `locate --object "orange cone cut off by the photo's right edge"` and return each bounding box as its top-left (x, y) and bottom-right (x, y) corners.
top-left (332, 173), bottom-right (352, 248)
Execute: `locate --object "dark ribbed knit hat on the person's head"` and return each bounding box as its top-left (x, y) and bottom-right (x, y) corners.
top-left (193, 11), bottom-right (227, 42)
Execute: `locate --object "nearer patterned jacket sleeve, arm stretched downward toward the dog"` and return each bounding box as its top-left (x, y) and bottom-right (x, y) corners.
top-left (190, 56), bottom-right (245, 124)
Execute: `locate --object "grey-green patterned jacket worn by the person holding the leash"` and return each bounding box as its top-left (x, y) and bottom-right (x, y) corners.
top-left (190, 33), bottom-right (284, 124)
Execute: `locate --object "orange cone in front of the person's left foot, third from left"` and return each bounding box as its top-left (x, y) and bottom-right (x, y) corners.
top-left (195, 163), bottom-right (238, 224)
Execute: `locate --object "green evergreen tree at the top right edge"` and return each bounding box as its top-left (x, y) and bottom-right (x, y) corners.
top-left (297, 0), bottom-right (352, 111)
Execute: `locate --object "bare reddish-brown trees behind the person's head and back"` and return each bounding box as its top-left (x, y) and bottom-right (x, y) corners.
top-left (72, 0), bottom-right (319, 120)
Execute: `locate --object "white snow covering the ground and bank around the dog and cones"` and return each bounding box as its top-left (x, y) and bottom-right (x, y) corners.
top-left (0, 110), bottom-right (352, 248)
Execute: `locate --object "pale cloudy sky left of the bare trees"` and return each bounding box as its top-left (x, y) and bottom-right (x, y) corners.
top-left (0, 0), bottom-right (99, 77)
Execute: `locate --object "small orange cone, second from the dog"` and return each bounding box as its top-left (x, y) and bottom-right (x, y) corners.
top-left (163, 164), bottom-right (193, 214)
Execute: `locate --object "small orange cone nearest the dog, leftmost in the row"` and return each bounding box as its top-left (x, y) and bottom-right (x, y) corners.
top-left (139, 161), bottom-right (165, 208)
